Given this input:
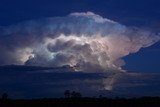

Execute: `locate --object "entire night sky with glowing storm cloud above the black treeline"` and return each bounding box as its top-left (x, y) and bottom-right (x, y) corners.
top-left (0, 0), bottom-right (160, 98)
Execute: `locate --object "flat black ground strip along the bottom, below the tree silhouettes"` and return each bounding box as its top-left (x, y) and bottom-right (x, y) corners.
top-left (0, 97), bottom-right (160, 107)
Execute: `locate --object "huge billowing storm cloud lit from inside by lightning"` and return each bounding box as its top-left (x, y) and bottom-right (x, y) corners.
top-left (0, 12), bottom-right (160, 71)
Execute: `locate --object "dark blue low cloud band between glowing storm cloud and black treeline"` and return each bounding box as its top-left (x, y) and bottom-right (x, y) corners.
top-left (0, 66), bottom-right (160, 98)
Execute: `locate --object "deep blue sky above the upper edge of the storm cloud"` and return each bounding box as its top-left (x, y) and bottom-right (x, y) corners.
top-left (0, 0), bottom-right (160, 25)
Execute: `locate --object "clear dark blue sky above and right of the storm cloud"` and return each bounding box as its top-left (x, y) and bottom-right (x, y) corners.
top-left (0, 0), bottom-right (160, 72)
